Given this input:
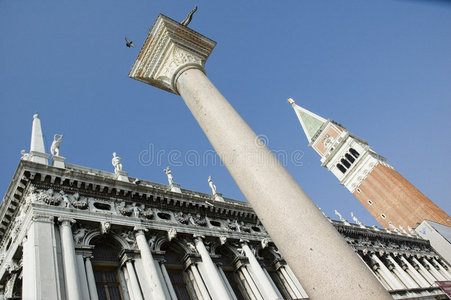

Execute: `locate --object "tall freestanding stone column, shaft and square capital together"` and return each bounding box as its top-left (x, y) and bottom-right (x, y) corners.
top-left (129, 15), bottom-right (391, 299)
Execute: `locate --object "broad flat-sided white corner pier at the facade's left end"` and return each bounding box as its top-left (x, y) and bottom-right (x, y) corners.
top-left (22, 215), bottom-right (63, 299)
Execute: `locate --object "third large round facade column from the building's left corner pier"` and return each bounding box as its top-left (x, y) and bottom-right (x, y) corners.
top-left (194, 237), bottom-right (229, 299)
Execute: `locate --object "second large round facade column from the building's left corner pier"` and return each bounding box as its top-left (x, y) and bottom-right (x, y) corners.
top-left (135, 227), bottom-right (169, 299)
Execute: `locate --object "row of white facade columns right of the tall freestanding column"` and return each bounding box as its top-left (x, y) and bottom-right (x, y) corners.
top-left (369, 253), bottom-right (451, 291)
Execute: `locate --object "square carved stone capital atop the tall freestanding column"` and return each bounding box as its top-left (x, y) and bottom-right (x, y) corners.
top-left (128, 14), bottom-right (216, 94)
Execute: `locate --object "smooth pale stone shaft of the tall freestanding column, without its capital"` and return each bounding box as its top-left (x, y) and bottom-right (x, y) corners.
top-left (175, 69), bottom-right (391, 299)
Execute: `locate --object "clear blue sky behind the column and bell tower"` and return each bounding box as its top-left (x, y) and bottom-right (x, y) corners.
top-left (0, 0), bottom-right (451, 225)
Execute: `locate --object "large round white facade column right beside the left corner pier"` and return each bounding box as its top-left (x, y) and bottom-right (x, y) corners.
top-left (58, 218), bottom-right (81, 300)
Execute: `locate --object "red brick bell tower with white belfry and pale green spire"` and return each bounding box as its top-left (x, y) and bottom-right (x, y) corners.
top-left (288, 99), bottom-right (451, 230)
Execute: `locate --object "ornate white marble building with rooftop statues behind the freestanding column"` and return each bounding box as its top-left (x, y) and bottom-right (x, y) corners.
top-left (0, 115), bottom-right (451, 300)
